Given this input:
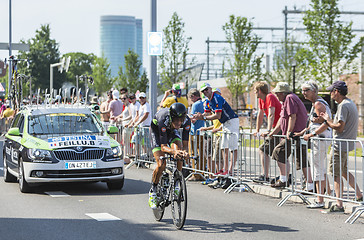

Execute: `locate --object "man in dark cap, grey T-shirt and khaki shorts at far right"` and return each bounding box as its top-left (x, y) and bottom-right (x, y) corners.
top-left (320, 81), bottom-right (363, 212)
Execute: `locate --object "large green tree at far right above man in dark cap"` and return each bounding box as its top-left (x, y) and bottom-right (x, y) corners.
top-left (299, 0), bottom-right (362, 85)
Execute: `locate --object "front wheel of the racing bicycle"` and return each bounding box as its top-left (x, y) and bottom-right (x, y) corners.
top-left (171, 171), bottom-right (187, 229)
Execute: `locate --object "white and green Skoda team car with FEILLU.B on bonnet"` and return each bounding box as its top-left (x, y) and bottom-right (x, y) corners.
top-left (3, 104), bottom-right (124, 192)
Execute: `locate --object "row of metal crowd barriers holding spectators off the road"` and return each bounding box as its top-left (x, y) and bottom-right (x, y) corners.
top-left (118, 125), bottom-right (364, 223)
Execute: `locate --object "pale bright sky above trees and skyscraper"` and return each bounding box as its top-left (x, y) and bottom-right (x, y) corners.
top-left (0, 0), bottom-right (364, 69)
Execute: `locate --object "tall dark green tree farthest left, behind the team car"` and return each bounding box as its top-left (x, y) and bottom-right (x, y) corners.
top-left (18, 24), bottom-right (64, 92)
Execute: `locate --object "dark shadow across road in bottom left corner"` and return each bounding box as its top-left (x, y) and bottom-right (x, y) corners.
top-left (0, 218), bottom-right (168, 240)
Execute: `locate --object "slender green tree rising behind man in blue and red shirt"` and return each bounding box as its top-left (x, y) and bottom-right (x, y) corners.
top-left (222, 15), bottom-right (263, 107)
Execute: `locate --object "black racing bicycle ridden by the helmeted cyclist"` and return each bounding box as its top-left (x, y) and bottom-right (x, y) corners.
top-left (153, 155), bottom-right (191, 229)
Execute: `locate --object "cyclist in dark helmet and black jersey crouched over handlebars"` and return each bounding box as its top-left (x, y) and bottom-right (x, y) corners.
top-left (149, 103), bottom-right (191, 209)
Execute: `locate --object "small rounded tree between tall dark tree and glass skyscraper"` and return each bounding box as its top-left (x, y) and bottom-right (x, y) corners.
top-left (62, 52), bottom-right (96, 87)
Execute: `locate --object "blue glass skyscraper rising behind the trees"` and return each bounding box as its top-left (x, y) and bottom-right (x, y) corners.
top-left (100, 16), bottom-right (143, 77)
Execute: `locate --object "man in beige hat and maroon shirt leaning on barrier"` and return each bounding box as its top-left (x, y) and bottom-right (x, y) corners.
top-left (268, 82), bottom-right (313, 190)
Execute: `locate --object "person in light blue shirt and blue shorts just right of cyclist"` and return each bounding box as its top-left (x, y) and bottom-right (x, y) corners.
top-left (188, 88), bottom-right (206, 180)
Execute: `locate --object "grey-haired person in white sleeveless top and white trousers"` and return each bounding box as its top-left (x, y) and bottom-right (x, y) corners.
top-left (297, 81), bottom-right (332, 208)
